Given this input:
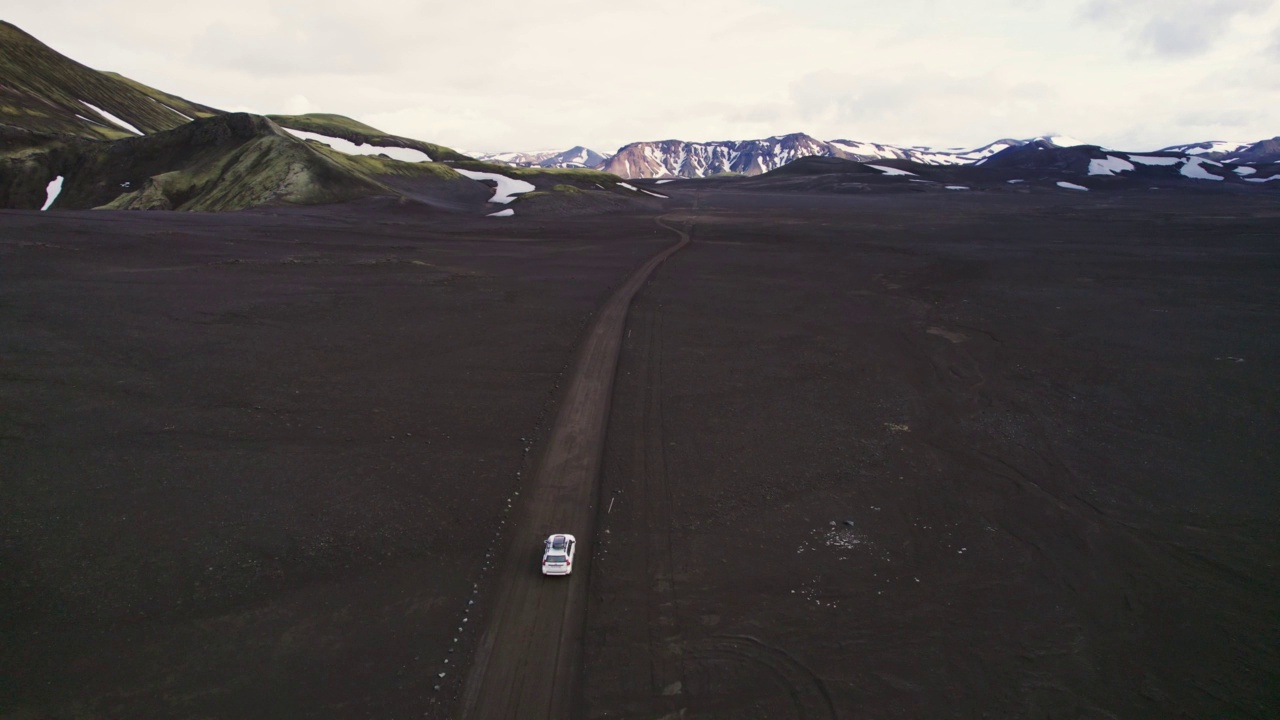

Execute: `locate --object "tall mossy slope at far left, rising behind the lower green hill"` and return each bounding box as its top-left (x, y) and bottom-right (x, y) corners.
top-left (0, 22), bottom-right (211, 140)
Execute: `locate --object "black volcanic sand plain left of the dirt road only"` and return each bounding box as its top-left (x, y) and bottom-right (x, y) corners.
top-left (0, 201), bottom-right (675, 717)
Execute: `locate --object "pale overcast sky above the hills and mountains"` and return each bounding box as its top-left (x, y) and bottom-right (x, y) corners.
top-left (0, 0), bottom-right (1280, 151)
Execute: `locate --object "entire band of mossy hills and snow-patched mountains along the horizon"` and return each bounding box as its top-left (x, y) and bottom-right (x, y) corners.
top-left (0, 20), bottom-right (1280, 215)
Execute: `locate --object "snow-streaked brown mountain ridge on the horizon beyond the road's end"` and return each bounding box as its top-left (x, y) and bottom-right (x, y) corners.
top-left (600, 133), bottom-right (1083, 178)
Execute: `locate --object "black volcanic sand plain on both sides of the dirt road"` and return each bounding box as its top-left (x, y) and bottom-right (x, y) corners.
top-left (0, 192), bottom-right (1280, 719)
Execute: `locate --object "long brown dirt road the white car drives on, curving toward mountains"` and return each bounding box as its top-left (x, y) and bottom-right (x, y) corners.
top-left (461, 218), bottom-right (689, 720)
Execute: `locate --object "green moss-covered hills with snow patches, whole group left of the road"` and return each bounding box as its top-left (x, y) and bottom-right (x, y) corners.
top-left (0, 22), bottom-right (640, 211)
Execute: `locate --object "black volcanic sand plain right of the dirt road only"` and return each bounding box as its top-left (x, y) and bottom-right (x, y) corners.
top-left (584, 193), bottom-right (1280, 720)
